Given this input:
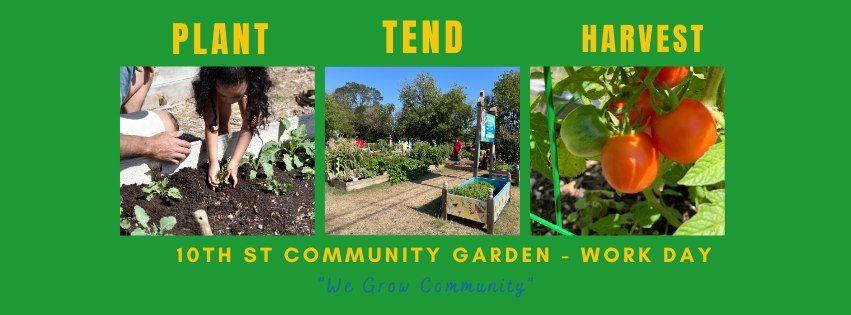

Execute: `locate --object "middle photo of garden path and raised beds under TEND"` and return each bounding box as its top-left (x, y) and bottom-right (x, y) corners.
top-left (324, 67), bottom-right (520, 235)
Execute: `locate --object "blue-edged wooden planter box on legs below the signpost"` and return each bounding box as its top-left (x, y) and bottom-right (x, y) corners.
top-left (443, 177), bottom-right (511, 234)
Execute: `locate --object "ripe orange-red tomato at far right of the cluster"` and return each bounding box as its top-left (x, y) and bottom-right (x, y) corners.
top-left (651, 98), bottom-right (718, 164)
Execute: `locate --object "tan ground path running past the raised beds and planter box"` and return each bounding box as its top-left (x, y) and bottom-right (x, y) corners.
top-left (325, 168), bottom-right (520, 235)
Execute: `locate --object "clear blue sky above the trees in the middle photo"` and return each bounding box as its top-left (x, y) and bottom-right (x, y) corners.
top-left (325, 67), bottom-right (519, 112)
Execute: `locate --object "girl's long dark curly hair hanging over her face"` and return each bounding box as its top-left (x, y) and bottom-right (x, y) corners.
top-left (192, 67), bottom-right (272, 133)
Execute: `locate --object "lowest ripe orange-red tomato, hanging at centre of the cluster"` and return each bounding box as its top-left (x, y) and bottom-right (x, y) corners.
top-left (600, 133), bottom-right (659, 194)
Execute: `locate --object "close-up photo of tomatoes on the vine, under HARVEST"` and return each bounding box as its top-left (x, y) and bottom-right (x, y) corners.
top-left (529, 66), bottom-right (725, 236)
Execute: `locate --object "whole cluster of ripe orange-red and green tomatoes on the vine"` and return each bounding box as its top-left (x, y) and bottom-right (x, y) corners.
top-left (561, 67), bottom-right (718, 193)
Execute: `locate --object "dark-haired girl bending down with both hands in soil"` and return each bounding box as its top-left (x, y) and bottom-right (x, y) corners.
top-left (192, 67), bottom-right (272, 189)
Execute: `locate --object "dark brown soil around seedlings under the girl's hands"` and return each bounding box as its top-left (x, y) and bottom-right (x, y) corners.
top-left (120, 166), bottom-right (314, 235)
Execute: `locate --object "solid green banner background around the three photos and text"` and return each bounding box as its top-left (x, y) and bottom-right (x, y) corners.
top-left (0, 1), bottom-right (851, 313)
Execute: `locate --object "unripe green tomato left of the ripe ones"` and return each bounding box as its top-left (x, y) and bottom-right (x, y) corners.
top-left (561, 105), bottom-right (612, 158)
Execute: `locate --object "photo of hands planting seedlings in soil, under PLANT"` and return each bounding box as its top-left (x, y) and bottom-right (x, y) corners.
top-left (119, 67), bottom-right (315, 236)
